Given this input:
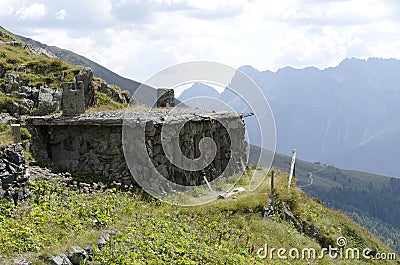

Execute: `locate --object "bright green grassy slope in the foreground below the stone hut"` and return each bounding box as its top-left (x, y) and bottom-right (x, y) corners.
top-left (0, 168), bottom-right (395, 264)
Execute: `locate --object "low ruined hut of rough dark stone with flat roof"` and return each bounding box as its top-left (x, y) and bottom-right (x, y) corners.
top-left (29, 110), bottom-right (247, 185)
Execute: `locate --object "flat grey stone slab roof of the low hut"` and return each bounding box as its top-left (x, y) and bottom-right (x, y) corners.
top-left (27, 108), bottom-right (242, 126)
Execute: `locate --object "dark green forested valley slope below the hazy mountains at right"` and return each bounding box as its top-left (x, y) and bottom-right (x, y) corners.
top-left (250, 146), bottom-right (400, 253)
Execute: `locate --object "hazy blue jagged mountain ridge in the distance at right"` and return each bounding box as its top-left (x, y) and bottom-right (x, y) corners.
top-left (180, 58), bottom-right (400, 177)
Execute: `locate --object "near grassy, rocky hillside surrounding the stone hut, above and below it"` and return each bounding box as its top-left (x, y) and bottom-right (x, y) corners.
top-left (0, 24), bottom-right (396, 264)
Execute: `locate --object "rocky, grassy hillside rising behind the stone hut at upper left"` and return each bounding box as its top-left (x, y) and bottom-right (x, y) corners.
top-left (0, 28), bottom-right (130, 118)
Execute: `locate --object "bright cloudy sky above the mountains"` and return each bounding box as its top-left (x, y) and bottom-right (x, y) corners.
top-left (0, 0), bottom-right (400, 82)
